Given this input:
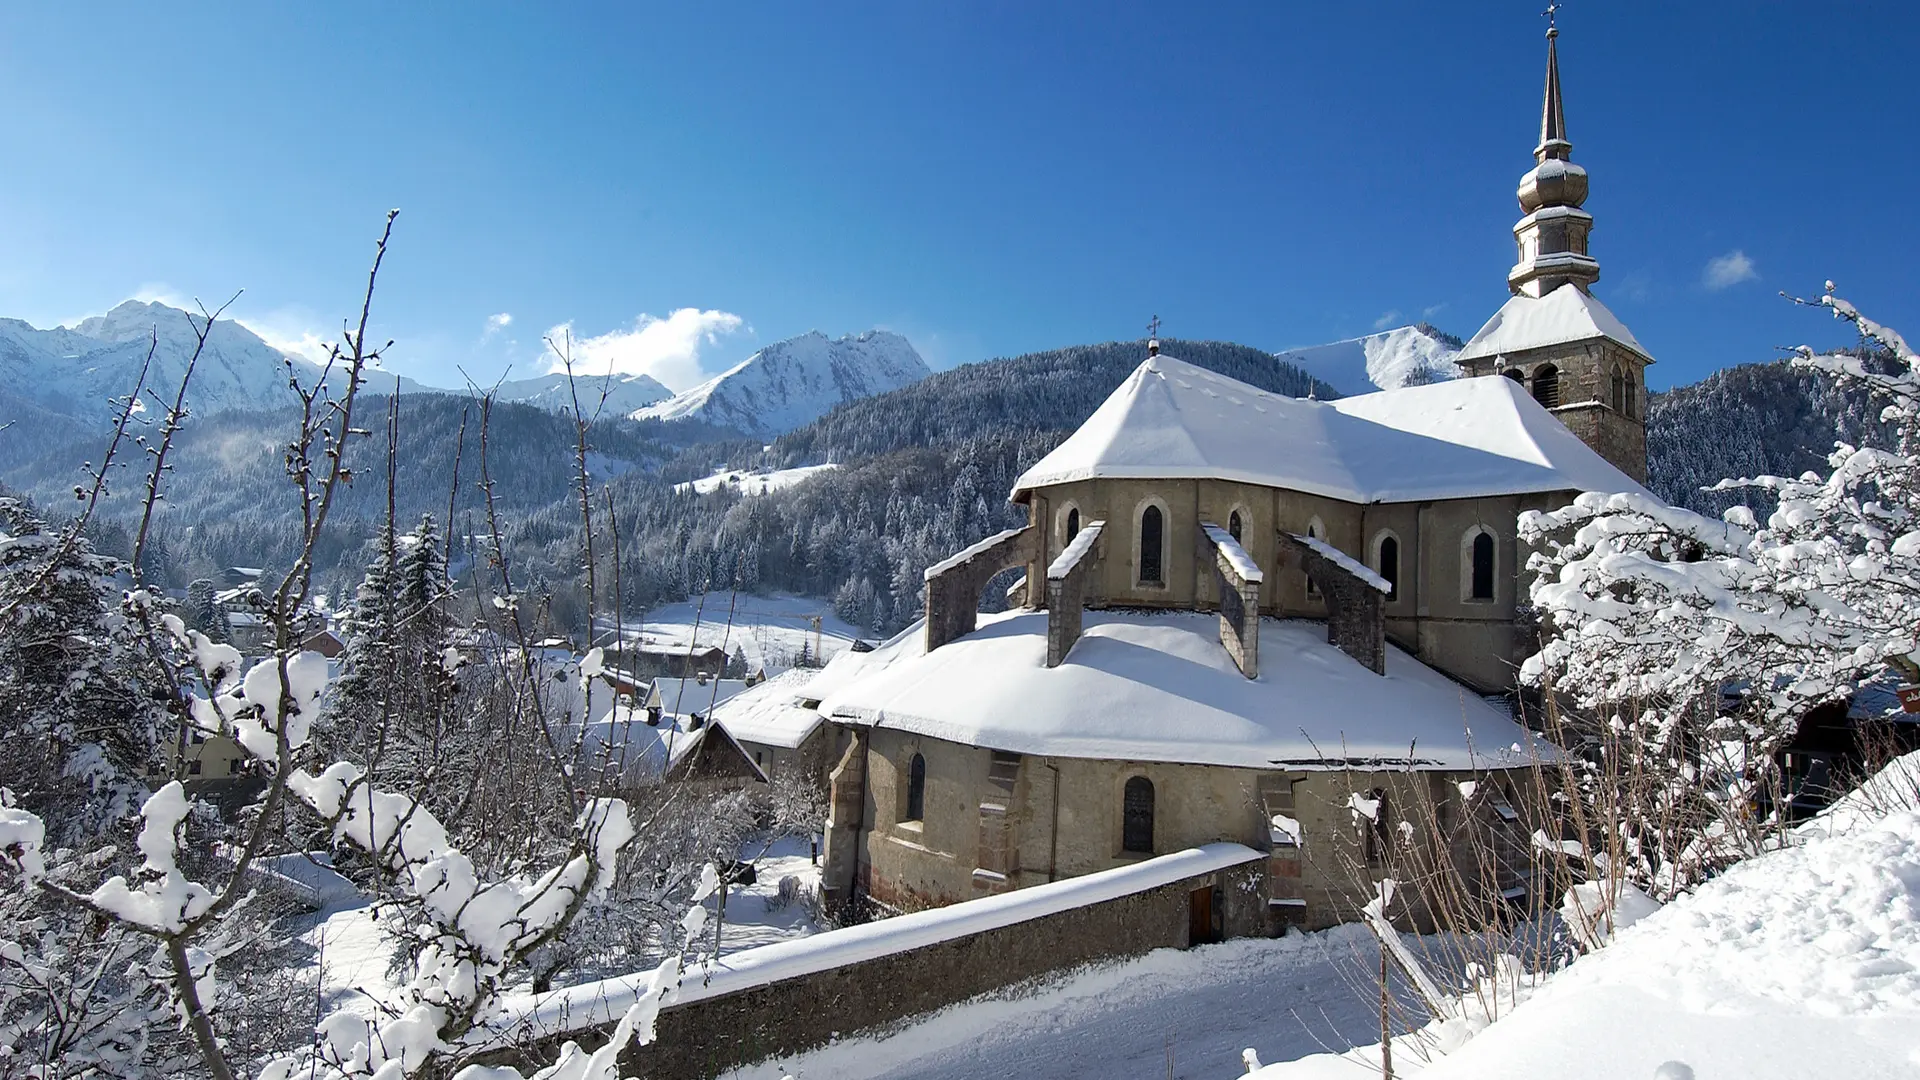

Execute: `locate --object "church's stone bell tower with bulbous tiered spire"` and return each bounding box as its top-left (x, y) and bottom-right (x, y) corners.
top-left (1455, 13), bottom-right (1653, 482)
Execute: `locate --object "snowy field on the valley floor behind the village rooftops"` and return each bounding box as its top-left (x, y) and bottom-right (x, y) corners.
top-left (599, 592), bottom-right (862, 675)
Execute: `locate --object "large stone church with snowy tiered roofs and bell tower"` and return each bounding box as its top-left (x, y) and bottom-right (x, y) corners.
top-left (797, 31), bottom-right (1653, 932)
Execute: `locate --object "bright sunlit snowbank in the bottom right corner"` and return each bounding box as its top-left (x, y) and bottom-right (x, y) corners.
top-left (1259, 755), bottom-right (1920, 1080)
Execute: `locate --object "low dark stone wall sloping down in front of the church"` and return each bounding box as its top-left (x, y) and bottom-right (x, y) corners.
top-left (484, 844), bottom-right (1267, 1080)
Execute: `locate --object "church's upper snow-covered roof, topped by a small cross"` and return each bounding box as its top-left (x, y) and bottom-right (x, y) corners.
top-left (1014, 356), bottom-right (1644, 503)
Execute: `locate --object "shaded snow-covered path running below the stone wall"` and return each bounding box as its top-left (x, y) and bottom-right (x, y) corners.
top-left (728, 914), bottom-right (1420, 1080)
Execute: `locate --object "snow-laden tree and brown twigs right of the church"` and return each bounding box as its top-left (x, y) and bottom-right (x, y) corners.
top-left (1521, 286), bottom-right (1920, 899)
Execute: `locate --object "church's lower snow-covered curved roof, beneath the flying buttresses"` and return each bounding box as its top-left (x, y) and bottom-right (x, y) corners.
top-left (820, 611), bottom-right (1548, 769)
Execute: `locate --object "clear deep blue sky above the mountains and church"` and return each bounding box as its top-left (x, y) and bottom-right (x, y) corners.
top-left (0, 0), bottom-right (1920, 388)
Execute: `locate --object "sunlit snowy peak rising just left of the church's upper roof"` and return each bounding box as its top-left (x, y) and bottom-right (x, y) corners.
top-left (634, 331), bottom-right (931, 438)
